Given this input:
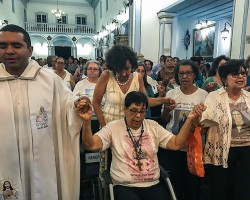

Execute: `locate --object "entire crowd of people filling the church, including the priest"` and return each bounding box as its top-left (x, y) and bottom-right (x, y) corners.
top-left (0, 25), bottom-right (250, 200)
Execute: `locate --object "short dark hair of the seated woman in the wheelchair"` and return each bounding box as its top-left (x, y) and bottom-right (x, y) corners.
top-left (125, 91), bottom-right (148, 108)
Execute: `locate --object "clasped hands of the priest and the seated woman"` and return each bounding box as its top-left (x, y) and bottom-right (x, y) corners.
top-left (74, 96), bottom-right (92, 121)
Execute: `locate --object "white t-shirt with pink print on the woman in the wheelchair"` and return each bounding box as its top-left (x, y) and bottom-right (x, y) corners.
top-left (96, 119), bottom-right (173, 187)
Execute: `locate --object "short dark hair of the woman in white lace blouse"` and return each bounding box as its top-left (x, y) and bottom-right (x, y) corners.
top-left (218, 59), bottom-right (246, 86)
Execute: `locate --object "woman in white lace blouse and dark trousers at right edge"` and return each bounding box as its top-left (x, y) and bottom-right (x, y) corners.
top-left (197, 60), bottom-right (250, 200)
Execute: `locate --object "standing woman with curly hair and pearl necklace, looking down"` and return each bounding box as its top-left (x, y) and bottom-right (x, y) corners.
top-left (93, 45), bottom-right (173, 127)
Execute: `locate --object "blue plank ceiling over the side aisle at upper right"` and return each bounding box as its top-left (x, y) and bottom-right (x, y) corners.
top-left (163, 0), bottom-right (234, 21)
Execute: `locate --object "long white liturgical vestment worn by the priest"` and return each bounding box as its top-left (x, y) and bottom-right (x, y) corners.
top-left (0, 61), bottom-right (81, 200)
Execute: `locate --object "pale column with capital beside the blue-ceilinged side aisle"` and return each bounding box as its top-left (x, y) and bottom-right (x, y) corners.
top-left (157, 11), bottom-right (174, 57)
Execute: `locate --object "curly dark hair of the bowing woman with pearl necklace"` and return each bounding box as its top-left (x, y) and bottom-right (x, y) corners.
top-left (106, 45), bottom-right (137, 73)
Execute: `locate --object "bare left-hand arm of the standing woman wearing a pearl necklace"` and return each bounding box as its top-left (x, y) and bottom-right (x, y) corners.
top-left (93, 70), bottom-right (109, 127)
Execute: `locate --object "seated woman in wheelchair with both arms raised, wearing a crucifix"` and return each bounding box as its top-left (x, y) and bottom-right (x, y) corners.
top-left (79, 91), bottom-right (205, 200)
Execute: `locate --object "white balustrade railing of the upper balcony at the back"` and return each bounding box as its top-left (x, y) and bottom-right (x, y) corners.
top-left (24, 22), bottom-right (96, 34)
